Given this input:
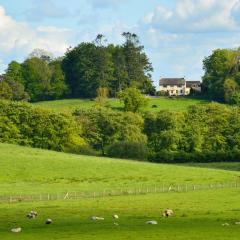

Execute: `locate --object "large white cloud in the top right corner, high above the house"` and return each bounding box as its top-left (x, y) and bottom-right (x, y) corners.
top-left (144, 0), bottom-right (240, 33)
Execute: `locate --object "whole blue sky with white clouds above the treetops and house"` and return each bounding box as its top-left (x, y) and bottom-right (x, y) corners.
top-left (0, 0), bottom-right (240, 88)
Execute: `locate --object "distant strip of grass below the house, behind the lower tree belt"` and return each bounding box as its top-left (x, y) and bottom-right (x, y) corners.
top-left (32, 97), bottom-right (208, 112)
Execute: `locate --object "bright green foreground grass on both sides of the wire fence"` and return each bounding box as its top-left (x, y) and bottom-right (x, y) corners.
top-left (0, 144), bottom-right (240, 240)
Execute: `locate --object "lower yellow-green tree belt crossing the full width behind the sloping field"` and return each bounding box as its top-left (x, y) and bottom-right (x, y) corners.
top-left (0, 98), bottom-right (240, 162)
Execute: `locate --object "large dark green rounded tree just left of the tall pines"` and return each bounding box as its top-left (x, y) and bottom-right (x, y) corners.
top-left (63, 39), bottom-right (113, 98)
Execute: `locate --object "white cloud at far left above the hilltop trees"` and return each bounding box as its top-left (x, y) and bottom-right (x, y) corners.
top-left (0, 6), bottom-right (68, 58)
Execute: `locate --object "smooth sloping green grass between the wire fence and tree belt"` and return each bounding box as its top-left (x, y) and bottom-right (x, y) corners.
top-left (0, 144), bottom-right (239, 194)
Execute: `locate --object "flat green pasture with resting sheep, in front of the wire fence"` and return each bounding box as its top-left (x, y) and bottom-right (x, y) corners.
top-left (0, 189), bottom-right (240, 240)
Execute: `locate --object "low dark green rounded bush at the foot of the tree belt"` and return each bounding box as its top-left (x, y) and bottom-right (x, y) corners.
top-left (107, 142), bottom-right (148, 160)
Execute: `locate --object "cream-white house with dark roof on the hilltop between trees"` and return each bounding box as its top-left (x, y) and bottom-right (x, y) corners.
top-left (159, 78), bottom-right (201, 96)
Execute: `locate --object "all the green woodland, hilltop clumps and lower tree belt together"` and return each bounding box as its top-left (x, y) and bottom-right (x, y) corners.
top-left (0, 33), bottom-right (240, 162)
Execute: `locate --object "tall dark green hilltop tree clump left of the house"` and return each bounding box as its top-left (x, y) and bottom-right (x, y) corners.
top-left (0, 32), bottom-right (155, 102)
